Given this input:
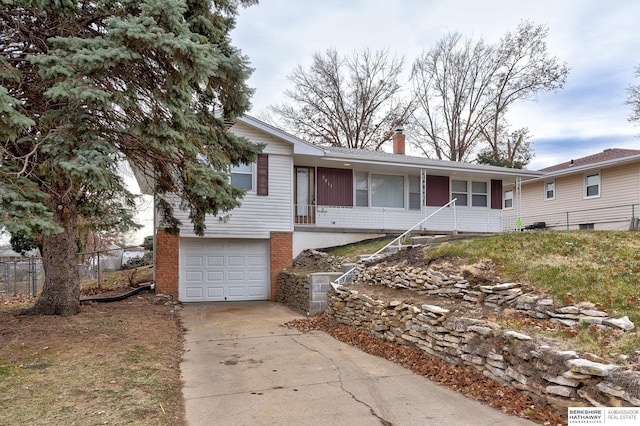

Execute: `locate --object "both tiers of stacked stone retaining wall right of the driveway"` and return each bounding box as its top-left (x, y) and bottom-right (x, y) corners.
top-left (326, 265), bottom-right (640, 410)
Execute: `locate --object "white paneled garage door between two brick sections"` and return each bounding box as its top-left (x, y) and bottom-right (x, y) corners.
top-left (179, 239), bottom-right (269, 302)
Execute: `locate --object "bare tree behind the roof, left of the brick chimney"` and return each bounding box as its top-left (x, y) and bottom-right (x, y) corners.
top-left (270, 49), bottom-right (411, 149)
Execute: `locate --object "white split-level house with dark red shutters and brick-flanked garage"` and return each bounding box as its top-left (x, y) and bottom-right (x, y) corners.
top-left (136, 116), bottom-right (541, 302)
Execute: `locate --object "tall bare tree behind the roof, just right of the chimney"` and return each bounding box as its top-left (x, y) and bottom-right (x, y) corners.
top-left (411, 33), bottom-right (497, 161)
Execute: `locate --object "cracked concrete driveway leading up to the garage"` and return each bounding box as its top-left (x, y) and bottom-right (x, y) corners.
top-left (180, 302), bottom-right (534, 426)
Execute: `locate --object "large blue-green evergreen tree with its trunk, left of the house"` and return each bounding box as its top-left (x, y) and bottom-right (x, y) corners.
top-left (0, 0), bottom-right (260, 315)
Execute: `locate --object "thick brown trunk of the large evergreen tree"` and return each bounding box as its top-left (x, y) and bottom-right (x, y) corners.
top-left (32, 203), bottom-right (80, 316)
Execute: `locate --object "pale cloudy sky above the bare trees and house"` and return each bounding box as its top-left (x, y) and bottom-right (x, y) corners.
top-left (232, 0), bottom-right (640, 169)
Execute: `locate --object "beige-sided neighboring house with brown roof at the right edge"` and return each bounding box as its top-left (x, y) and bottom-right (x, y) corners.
top-left (504, 149), bottom-right (640, 230)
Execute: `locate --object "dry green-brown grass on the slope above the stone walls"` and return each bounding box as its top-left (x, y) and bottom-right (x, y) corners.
top-left (427, 231), bottom-right (640, 356)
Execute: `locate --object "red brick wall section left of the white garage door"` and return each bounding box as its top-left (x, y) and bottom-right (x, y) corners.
top-left (155, 229), bottom-right (180, 300)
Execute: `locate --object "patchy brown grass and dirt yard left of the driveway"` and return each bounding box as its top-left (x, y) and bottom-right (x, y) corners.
top-left (0, 292), bottom-right (184, 425)
